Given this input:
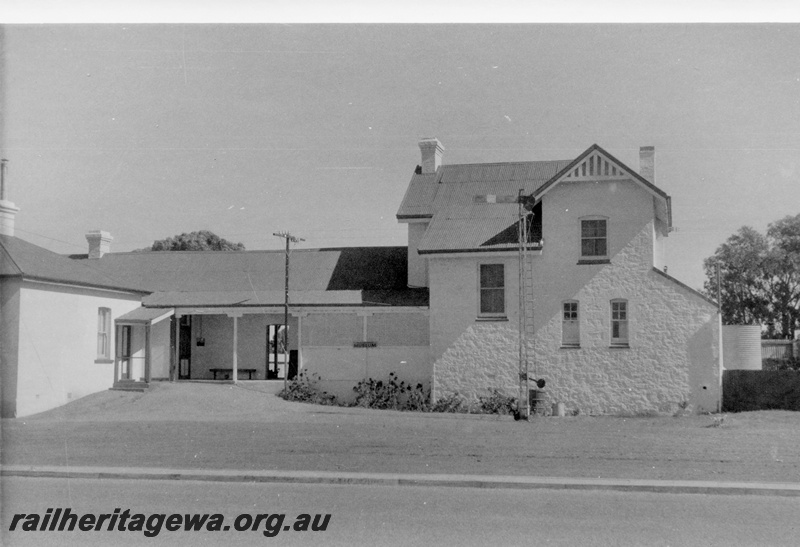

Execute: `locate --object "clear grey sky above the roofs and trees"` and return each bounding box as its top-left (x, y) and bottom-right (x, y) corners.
top-left (1, 12), bottom-right (800, 287)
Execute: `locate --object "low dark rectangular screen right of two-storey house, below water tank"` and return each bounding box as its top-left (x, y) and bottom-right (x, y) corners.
top-left (722, 370), bottom-right (800, 412)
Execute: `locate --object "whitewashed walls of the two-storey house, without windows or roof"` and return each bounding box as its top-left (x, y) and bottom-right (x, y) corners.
top-left (429, 181), bottom-right (720, 414)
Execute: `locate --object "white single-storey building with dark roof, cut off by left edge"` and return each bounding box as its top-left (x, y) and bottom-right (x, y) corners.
top-left (0, 220), bottom-right (148, 417)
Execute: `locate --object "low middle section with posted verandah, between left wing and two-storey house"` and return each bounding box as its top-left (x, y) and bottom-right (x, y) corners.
top-left (73, 247), bottom-right (430, 399)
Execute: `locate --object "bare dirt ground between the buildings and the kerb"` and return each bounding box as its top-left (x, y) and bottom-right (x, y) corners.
top-left (0, 382), bottom-right (800, 482)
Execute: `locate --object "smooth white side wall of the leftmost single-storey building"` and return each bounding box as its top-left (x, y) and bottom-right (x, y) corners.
top-left (3, 281), bottom-right (141, 416)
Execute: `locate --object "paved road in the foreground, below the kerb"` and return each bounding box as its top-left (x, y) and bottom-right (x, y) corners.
top-left (0, 478), bottom-right (800, 546)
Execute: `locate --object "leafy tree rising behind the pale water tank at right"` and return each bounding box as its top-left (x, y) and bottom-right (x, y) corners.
top-left (703, 214), bottom-right (800, 338)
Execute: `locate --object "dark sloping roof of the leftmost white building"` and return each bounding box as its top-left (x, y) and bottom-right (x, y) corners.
top-left (0, 235), bottom-right (149, 294)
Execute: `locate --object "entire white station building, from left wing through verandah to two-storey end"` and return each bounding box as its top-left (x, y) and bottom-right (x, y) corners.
top-left (0, 139), bottom-right (722, 416)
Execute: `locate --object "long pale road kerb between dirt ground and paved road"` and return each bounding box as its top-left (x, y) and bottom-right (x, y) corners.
top-left (0, 465), bottom-right (800, 497)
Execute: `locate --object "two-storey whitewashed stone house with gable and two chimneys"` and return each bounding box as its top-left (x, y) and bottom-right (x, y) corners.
top-left (397, 139), bottom-right (721, 413)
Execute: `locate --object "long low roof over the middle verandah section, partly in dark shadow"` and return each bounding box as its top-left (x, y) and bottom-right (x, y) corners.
top-left (76, 247), bottom-right (428, 307)
